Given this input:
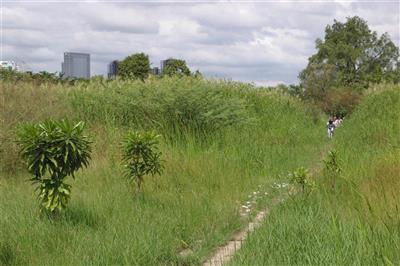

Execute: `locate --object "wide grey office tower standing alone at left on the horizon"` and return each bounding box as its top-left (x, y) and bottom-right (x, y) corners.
top-left (61, 52), bottom-right (90, 79)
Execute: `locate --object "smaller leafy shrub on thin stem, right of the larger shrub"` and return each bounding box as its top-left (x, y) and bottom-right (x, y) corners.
top-left (123, 131), bottom-right (163, 191)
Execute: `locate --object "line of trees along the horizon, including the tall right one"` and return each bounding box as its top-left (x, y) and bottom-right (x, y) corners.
top-left (0, 16), bottom-right (400, 116)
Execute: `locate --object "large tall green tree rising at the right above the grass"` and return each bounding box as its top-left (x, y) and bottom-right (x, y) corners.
top-left (299, 16), bottom-right (400, 96)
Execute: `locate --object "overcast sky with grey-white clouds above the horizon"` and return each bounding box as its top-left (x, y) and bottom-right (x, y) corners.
top-left (1, 0), bottom-right (400, 85)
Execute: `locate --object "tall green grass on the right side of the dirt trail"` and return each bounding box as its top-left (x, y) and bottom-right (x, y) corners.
top-left (230, 86), bottom-right (400, 265)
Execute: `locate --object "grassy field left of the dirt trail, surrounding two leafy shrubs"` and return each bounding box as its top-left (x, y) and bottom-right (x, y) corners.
top-left (0, 78), bottom-right (324, 265)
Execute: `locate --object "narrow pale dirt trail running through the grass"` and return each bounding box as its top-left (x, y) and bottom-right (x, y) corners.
top-left (202, 143), bottom-right (331, 266)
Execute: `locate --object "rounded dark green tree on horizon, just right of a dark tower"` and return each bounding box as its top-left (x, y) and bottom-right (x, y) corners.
top-left (118, 53), bottom-right (150, 80)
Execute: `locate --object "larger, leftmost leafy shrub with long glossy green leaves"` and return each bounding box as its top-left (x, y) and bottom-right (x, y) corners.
top-left (17, 120), bottom-right (91, 213)
